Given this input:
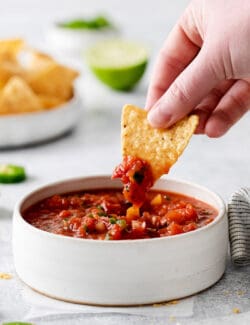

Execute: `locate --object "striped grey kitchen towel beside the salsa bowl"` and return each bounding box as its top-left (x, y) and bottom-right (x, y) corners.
top-left (228, 187), bottom-right (250, 266)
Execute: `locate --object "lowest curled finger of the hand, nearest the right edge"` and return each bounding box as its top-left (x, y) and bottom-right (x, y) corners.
top-left (204, 80), bottom-right (250, 138)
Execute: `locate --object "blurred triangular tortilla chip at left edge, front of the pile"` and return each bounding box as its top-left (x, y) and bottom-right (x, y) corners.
top-left (0, 77), bottom-right (42, 114)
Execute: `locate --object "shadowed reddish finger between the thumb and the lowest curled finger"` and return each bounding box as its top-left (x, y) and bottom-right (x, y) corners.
top-left (194, 80), bottom-right (235, 134)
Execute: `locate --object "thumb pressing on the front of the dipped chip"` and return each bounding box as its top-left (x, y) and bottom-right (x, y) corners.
top-left (148, 50), bottom-right (220, 128)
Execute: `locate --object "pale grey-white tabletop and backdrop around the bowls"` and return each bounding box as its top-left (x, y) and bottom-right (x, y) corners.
top-left (0, 0), bottom-right (250, 325)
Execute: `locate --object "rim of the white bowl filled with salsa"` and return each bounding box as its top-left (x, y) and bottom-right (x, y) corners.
top-left (13, 174), bottom-right (227, 245)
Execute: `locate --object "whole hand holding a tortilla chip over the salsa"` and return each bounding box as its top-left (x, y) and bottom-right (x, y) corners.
top-left (146, 0), bottom-right (250, 137)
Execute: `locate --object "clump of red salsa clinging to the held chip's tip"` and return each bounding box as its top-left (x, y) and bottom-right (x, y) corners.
top-left (112, 156), bottom-right (154, 207)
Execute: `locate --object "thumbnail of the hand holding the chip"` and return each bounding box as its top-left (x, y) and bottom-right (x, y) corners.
top-left (148, 104), bottom-right (171, 128)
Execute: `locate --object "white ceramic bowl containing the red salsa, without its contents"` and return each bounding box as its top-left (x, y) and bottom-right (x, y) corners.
top-left (13, 176), bottom-right (228, 305)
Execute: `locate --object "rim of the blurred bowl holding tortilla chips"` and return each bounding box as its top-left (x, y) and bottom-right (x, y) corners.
top-left (0, 86), bottom-right (80, 123)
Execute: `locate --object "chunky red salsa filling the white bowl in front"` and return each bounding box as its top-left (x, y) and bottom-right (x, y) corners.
top-left (23, 189), bottom-right (218, 240)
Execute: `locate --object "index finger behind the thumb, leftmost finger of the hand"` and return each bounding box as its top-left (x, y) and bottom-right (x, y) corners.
top-left (146, 8), bottom-right (200, 110)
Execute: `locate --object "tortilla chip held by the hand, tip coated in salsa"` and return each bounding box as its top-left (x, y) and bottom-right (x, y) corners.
top-left (115, 105), bottom-right (198, 207)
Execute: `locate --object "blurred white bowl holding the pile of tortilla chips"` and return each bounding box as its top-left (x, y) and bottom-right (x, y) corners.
top-left (0, 92), bottom-right (81, 148)
